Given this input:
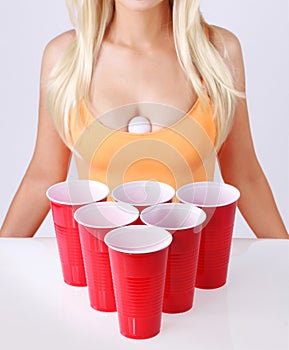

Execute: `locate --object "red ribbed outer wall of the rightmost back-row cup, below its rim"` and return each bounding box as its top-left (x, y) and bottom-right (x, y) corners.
top-left (196, 203), bottom-right (236, 289)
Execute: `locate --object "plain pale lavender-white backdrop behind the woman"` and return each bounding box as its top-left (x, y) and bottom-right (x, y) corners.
top-left (0, 0), bottom-right (289, 237)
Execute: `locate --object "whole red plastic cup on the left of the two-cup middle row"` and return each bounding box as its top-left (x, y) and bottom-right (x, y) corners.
top-left (74, 202), bottom-right (139, 312)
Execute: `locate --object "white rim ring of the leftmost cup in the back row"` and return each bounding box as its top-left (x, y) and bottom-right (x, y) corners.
top-left (46, 179), bottom-right (109, 206)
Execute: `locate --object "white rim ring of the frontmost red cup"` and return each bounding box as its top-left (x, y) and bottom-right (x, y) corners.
top-left (104, 225), bottom-right (173, 254)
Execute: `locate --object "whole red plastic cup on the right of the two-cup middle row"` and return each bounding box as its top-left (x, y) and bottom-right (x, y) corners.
top-left (141, 203), bottom-right (206, 313)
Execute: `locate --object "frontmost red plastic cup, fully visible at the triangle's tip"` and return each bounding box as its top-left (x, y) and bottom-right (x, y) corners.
top-left (105, 225), bottom-right (172, 339)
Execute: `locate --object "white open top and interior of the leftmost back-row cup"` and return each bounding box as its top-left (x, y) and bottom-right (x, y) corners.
top-left (46, 180), bottom-right (109, 205)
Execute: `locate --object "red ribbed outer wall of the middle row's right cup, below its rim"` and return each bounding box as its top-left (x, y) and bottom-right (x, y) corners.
top-left (163, 229), bottom-right (201, 313)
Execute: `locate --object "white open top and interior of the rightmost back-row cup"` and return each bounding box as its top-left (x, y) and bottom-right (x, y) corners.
top-left (176, 182), bottom-right (240, 208)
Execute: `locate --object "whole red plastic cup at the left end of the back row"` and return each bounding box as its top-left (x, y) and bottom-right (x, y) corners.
top-left (46, 180), bottom-right (109, 286)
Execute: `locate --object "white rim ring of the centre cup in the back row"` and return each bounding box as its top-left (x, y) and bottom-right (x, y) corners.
top-left (111, 180), bottom-right (176, 207)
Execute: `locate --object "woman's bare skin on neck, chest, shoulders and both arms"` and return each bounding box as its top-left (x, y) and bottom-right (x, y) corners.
top-left (0, 0), bottom-right (288, 239)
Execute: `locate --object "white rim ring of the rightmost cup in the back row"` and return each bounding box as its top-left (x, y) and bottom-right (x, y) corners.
top-left (176, 181), bottom-right (241, 208)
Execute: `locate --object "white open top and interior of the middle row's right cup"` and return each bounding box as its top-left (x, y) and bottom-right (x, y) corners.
top-left (141, 203), bottom-right (206, 230)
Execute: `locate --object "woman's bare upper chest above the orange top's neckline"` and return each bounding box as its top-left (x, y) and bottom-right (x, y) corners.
top-left (87, 43), bottom-right (197, 130)
